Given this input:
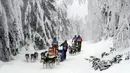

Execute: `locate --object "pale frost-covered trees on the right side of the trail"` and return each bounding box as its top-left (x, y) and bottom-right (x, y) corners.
top-left (87, 0), bottom-right (130, 49)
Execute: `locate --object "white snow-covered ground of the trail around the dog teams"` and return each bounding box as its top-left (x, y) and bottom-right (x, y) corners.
top-left (0, 39), bottom-right (130, 73)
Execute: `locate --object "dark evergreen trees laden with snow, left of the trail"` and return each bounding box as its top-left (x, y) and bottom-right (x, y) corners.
top-left (0, 0), bottom-right (74, 61)
